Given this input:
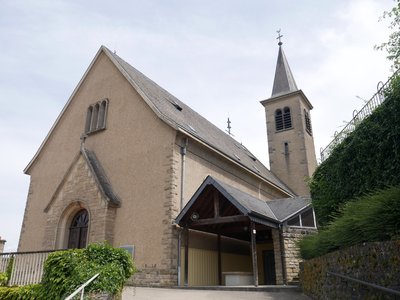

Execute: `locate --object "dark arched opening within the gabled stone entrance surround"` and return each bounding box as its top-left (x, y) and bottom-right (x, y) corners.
top-left (68, 209), bottom-right (89, 249)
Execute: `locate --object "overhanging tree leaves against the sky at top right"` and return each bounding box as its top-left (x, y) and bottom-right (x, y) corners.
top-left (375, 0), bottom-right (400, 70)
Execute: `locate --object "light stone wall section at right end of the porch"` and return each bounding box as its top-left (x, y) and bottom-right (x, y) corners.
top-left (282, 227), bottom-right (316, 283)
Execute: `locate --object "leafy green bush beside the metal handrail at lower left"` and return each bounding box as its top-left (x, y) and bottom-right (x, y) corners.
top-left (42, 244), bottom-right (135, 299)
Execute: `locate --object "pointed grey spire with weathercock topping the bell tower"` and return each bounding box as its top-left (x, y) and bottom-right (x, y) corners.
top-left (271, 29), bottom-right (298, 98)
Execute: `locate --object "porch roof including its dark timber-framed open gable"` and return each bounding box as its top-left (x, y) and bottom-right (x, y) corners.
top-left (176, 176), bottom-right (311, 231)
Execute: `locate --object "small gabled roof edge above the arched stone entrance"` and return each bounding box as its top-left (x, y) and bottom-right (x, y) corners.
top-left (44, 148), bottom-right (121, 212)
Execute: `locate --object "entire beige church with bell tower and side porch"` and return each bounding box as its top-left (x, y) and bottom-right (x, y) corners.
top-left (18, 42), bottom-right (316, 286)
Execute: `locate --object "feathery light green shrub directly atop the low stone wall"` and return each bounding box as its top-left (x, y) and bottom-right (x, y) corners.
top-left (299, 186), bottom-right (400, 259)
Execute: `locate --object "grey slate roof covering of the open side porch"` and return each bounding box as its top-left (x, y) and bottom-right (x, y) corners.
top-left (175, 176), bottom-right (311, 227)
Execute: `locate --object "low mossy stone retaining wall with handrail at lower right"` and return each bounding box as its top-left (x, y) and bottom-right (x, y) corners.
top-left (300, 240), bottom-right (400, 299)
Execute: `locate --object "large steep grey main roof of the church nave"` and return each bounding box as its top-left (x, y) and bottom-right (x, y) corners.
top-left (24, 46), bottom-right (294, 196)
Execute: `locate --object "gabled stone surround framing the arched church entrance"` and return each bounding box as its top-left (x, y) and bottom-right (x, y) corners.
top-left (43, 155), bottom-right (116, 249)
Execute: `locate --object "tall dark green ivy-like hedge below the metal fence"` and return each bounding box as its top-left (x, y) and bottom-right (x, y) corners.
top-left (310, 78), bottom-right (400, 226)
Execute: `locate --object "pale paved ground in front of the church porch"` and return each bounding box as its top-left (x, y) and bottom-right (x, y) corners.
top-left (122, 287), bottom-right (310, 300)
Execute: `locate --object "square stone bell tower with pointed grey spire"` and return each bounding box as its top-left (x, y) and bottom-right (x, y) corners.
top-left (261, 37), bottom-right (317, 196)
